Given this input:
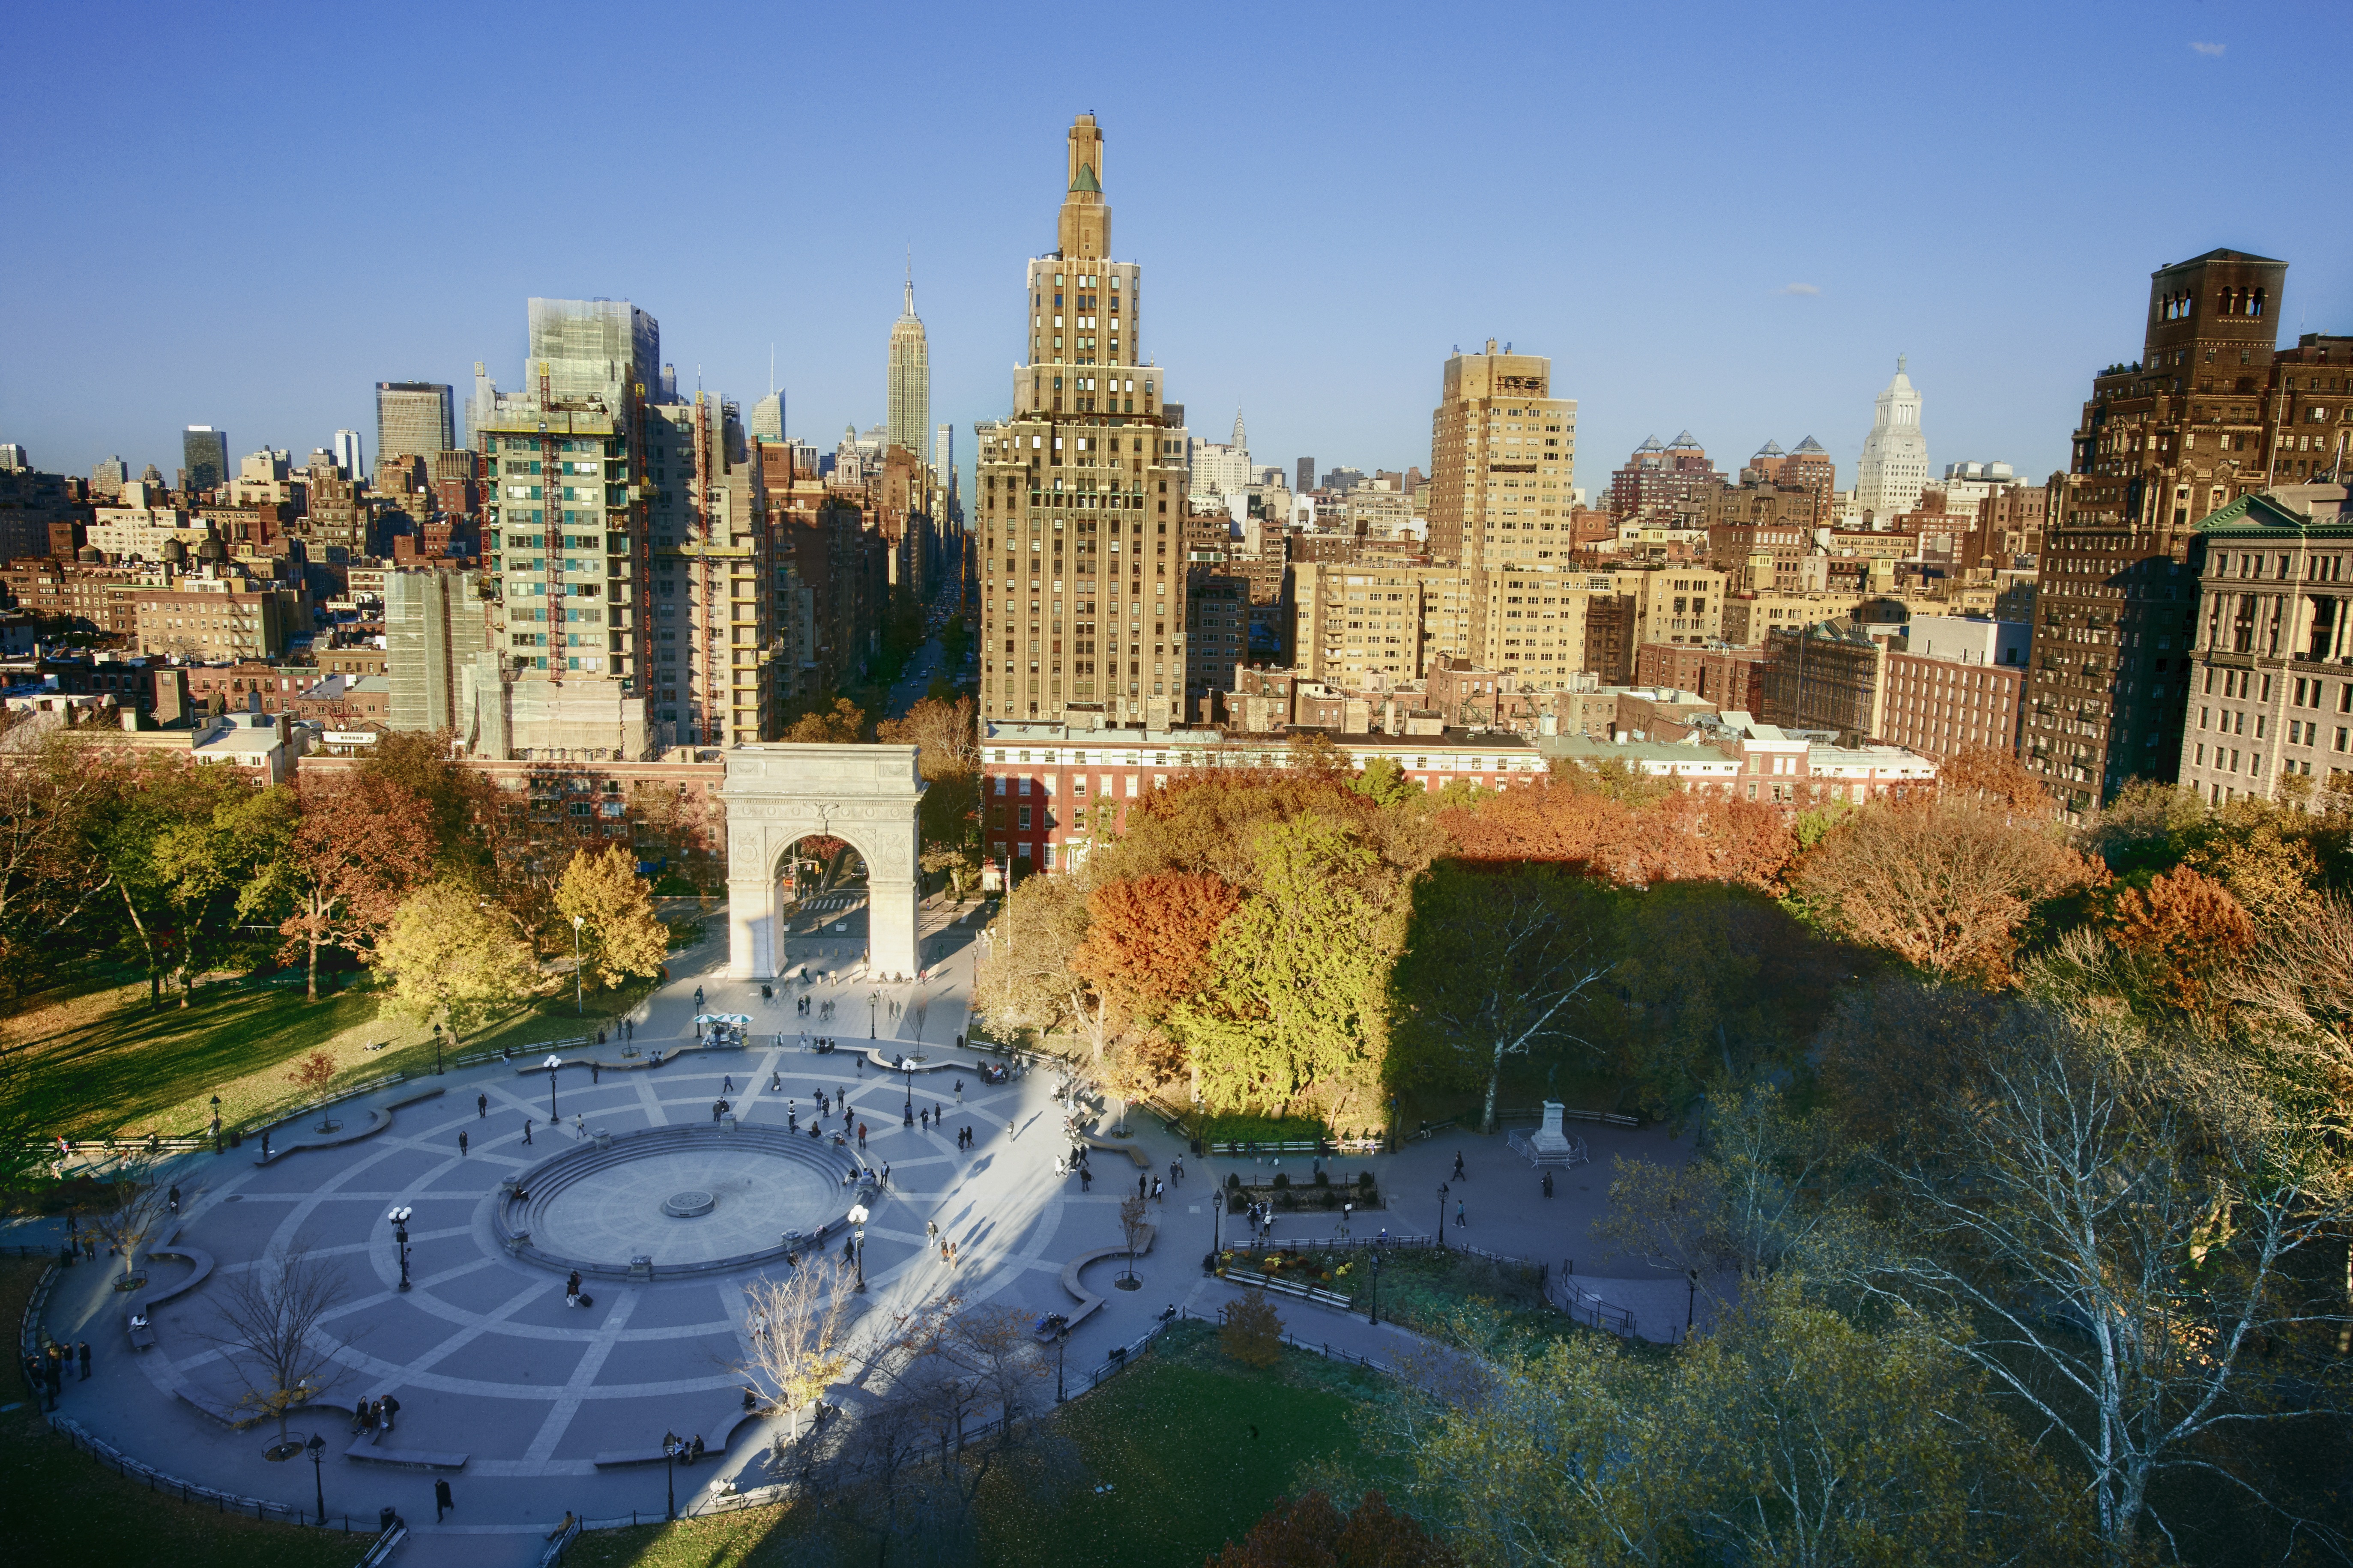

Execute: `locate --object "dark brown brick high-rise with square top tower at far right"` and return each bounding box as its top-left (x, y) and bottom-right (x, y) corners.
top-left (2021, 250), bottom-right (2306, 817)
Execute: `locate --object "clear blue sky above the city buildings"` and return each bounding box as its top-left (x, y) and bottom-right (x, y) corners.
top-left (0, 0), bottom-right (2353, 501)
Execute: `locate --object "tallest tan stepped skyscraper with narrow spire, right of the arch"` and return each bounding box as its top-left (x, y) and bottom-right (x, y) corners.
top-left (974, 115), bottom-right (1186, 728)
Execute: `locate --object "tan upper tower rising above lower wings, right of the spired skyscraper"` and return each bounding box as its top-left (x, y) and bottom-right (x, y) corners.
top-left (1431, 337), bottom-right (1576, 572)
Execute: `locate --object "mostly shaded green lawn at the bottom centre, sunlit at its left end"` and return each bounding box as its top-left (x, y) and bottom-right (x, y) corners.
top-left (565, 1323), bottom-right (1384, 1568)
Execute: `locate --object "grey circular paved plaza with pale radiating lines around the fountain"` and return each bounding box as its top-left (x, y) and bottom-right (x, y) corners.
top-left (12, 885), bottom-right (1685, 1563)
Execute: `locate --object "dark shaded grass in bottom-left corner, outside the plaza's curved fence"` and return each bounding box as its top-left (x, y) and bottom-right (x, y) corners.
top-left (0, 1257), bottom-right (357, 1568)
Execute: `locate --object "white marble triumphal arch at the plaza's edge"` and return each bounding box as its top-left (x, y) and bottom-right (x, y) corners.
top-left (720, 744), bottom-right (922, 980)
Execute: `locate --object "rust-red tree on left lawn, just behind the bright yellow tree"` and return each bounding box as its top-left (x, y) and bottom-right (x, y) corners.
top-left (261, 770), bottom-right (433, 1001)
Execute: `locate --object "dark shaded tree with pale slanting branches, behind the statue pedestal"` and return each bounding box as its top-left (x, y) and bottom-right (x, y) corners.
top-left (1390, 862), bottom-right (1617, 1132)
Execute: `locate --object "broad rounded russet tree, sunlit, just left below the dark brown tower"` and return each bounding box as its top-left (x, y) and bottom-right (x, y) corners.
top-left (1791, 796), bottom-right (2094, 982)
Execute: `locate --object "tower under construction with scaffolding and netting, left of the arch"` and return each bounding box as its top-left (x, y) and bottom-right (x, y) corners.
top-left (473, 299), bottom-right (664, 761)
